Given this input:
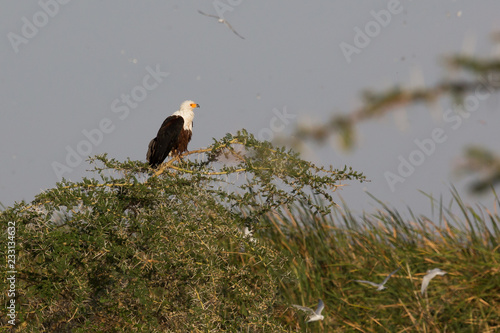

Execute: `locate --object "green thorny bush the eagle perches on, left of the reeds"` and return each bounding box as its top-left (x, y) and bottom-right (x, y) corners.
top-left (0, 130), bottom-right (365, 332)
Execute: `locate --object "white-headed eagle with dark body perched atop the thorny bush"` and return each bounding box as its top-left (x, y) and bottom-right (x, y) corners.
top-left (146, 101), bottom-right (200, 168)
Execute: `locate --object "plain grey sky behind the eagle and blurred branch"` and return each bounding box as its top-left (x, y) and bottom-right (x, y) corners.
top-left (0, 0), bottom-right (500, 218)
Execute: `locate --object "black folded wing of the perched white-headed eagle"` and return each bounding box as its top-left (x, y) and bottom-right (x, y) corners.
top-left (146, 116), bottom-right (184, 168)
